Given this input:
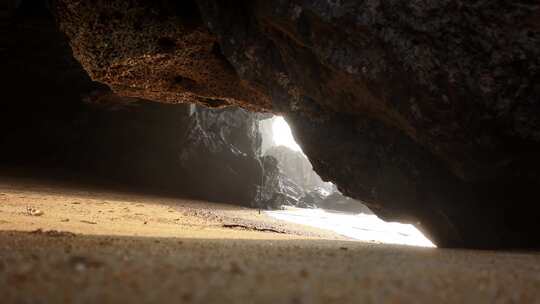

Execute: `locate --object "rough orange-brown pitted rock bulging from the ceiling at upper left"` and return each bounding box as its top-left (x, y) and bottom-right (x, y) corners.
top-left (52, 0), bottom-right (269, 109)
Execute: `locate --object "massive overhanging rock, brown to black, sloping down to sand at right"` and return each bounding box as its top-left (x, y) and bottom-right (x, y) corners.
top-left (47, 0), bottom-right (540, 248)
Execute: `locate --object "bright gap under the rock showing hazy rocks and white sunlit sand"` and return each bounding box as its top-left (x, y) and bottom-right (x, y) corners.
top-left (259, 116), bottom-right (435, 247)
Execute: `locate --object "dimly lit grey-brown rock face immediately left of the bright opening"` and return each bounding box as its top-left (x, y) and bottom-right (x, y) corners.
top-left (179, 107), bottom-right (266, 206)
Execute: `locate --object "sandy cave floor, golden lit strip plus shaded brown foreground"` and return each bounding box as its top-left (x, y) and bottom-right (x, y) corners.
top-left (0, 178), bottom-right (540, 303)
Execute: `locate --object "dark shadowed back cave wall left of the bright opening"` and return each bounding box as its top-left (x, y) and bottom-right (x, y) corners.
top-left (0, 1), bottom-right (264, 206)
